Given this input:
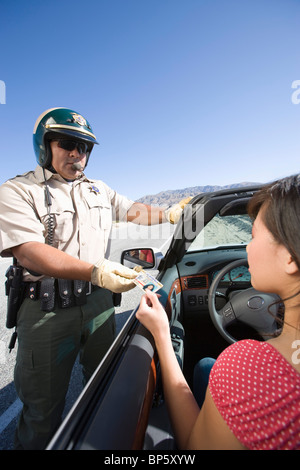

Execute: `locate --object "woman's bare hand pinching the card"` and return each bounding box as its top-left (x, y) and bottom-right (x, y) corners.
top-left (136, 289), bottom-right (170, 341)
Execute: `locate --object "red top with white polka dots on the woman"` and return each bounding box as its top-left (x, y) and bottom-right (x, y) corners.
top-left (209, 340), bottom-right (300, 450)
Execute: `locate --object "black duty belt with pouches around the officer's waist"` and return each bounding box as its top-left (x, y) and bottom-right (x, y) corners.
top-left (24, 278), bottom-right (99, 312)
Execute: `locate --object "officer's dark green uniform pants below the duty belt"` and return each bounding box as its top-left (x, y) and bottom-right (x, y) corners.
top-left (15, 289), bottom-right (115, 449)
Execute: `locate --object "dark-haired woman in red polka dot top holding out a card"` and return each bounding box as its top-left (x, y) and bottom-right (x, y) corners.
top-left (137, 175), bottom-right (300, 450)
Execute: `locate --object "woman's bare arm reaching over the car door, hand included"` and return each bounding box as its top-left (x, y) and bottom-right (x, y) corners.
top-left (136, 290), bottom-right (243, 450)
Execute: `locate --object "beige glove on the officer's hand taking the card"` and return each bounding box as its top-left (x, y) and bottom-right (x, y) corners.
top-left (91, 259), bottom-right (138, 294)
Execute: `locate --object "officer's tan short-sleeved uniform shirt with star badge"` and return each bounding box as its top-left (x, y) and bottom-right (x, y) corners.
top-left (0, 166), bottom-right (134, 276)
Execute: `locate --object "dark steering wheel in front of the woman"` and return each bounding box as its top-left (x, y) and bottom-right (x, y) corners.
top-left (208, 259), bottom-right (280, 343)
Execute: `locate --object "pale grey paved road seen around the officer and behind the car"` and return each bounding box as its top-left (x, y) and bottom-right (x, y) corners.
top-left (0, 224), bottom-right (173, 450)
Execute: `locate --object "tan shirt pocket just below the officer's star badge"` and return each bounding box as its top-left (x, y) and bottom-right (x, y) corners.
top-left (86, 194), bottom-right (112, 230)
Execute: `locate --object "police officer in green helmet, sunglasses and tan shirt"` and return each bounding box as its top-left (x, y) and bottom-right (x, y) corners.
top-left (0, 108), bottom-right (191, 449)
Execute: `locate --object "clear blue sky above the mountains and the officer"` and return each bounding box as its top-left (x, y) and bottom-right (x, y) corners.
top-left (0, 0), bottom-right (300, 199)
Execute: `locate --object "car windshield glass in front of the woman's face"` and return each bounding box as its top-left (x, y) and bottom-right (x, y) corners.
top-left (187, 214), bottom-right (252, 252)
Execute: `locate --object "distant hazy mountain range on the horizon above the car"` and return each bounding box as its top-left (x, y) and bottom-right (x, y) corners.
top-left (137, 182), bottom-right (259, 206)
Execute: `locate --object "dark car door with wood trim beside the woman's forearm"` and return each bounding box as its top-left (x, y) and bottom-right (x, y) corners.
top-left (47, 315), bottom-right (156, 450)
